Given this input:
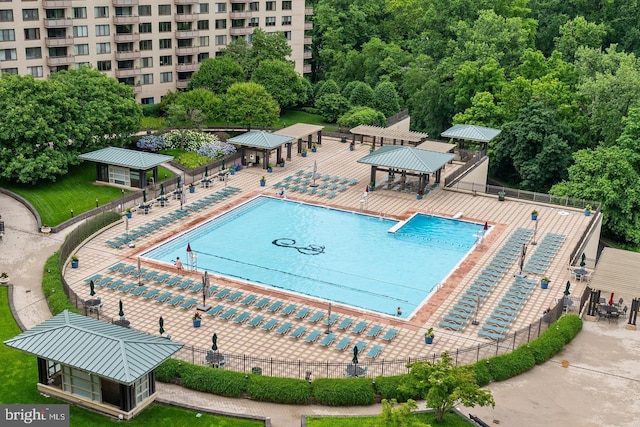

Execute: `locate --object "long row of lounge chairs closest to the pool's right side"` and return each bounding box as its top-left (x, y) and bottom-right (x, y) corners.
top-left (438, 228), bottom-right (533, 331)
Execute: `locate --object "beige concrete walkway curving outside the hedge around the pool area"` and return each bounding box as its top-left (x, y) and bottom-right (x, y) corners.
top-left (0, 194), bottom-right (640, 427)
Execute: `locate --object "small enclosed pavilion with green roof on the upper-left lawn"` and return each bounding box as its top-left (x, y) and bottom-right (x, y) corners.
top-left (79, 147), bottom-right (173, 188)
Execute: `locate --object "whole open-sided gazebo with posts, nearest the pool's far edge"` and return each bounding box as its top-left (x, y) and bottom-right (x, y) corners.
top-left (358, 145), bottom-right (454, 188)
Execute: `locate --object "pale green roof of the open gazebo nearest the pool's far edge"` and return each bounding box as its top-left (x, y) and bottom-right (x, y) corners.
top-left (358, 145), bottom-right (454, 173)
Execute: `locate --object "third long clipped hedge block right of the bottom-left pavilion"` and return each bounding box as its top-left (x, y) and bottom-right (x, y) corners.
top-left (313, 378), bottom-right (375, 406)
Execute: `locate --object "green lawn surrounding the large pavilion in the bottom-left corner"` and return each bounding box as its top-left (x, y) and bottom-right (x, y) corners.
top-left (0, 286), bottom-right (264, 427)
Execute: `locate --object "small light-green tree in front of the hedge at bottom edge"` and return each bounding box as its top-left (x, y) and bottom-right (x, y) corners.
top-left (400, 352), bottom-right (495, 421)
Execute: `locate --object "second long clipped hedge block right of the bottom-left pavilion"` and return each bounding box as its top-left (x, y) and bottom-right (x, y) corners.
top-left (247, 375), bottom-right (311, 405)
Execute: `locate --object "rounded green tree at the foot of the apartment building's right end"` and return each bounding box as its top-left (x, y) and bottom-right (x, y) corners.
top-left (251, 59), bottom-right (307, 109)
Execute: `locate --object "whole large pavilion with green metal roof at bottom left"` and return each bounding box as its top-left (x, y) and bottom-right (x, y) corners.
top-left (4, 310), bottom-right (183, 419)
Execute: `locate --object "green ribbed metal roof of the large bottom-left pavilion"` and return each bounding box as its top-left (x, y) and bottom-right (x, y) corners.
top-left (4, 310), bottom-right (184, 384)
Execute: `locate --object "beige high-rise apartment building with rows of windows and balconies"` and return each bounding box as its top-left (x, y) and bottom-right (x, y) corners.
top-left (0, 0), bottom-right (313, 104)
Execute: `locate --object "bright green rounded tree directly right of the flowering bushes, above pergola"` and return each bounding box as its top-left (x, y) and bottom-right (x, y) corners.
top-left (224, 83), bottom-right (280, 127)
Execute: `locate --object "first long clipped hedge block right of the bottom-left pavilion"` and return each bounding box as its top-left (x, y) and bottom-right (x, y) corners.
top-left (180, 362), bottom-right (247, 397)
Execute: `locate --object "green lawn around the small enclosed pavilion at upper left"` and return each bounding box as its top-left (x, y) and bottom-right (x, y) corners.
top-left (0, 162), bottom-right (174, 226)
